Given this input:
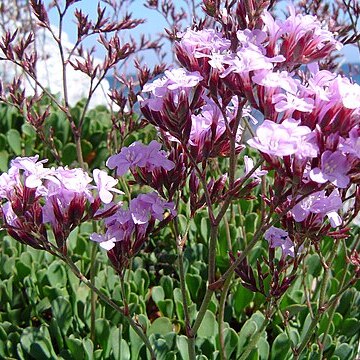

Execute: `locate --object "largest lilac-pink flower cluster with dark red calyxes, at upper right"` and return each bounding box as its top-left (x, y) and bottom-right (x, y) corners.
top-left (142, 7), bottom-right (360, 255)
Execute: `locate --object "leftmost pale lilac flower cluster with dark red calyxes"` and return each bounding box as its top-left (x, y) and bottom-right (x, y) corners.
top-left (0, 155), bottom-right (122, 251)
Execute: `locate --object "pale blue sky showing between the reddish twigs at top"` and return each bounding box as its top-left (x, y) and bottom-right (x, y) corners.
top-left (45, 0), bottom-right (360, 66)
